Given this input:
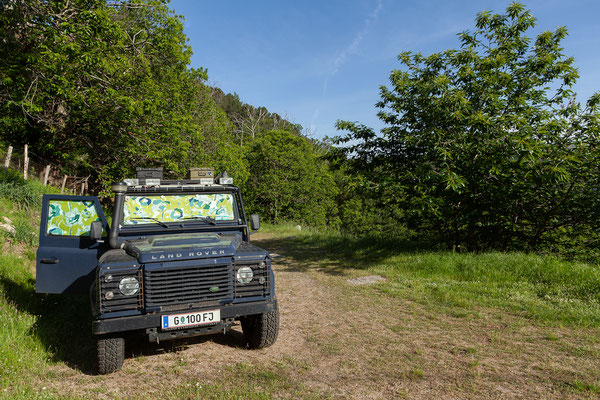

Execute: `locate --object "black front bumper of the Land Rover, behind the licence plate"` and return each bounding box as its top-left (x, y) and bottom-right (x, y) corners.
top-left (92, 300), bottom-right (277, 335)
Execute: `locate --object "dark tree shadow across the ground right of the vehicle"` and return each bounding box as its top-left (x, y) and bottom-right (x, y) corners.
top-left (254, 234), bottom-right (436, 275)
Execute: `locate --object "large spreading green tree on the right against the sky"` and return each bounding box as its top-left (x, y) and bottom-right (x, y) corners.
top-left (337, 3), bottom-right (600, 250)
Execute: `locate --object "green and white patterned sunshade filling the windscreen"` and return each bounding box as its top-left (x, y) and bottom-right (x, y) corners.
top-left (123, 193), bottom-right (234, 225)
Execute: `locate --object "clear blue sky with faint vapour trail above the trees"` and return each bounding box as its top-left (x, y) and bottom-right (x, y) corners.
top-left (170, 0), bottom-right (600, 138)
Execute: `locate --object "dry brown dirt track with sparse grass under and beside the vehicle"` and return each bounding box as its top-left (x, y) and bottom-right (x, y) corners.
top-left (44, 235), bottom-right (600, 399)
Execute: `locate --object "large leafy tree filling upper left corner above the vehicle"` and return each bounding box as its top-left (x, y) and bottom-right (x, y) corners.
top-left (0, 0), bottom-right (246, 191)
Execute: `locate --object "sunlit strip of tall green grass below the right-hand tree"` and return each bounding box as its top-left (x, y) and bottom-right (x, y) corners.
top-left (376, 252), bottom-right (600, 326)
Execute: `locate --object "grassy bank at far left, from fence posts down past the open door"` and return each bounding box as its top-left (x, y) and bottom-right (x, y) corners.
top-left (0, 169), bottom-right (89, 399)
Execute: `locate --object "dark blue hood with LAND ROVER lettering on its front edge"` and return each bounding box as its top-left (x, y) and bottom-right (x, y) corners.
top-left (124, 233), bottom-right (242, 263)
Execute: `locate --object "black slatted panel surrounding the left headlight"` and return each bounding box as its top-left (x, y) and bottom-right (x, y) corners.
top-left (98, 269), bottom-right (143, 313)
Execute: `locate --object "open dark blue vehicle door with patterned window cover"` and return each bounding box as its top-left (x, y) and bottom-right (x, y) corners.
top-left (36, 195), bottom-right (108, 293)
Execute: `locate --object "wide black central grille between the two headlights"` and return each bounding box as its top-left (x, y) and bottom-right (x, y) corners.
top-left (144, 264), bottom-right (233, 307)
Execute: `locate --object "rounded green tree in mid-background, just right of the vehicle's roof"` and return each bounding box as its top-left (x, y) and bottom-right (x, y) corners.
top-left (246, 130), bottom-right (336, 226)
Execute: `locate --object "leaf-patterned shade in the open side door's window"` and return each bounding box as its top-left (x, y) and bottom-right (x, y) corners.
top-left (46, 200), bottom-right (100, 236)
